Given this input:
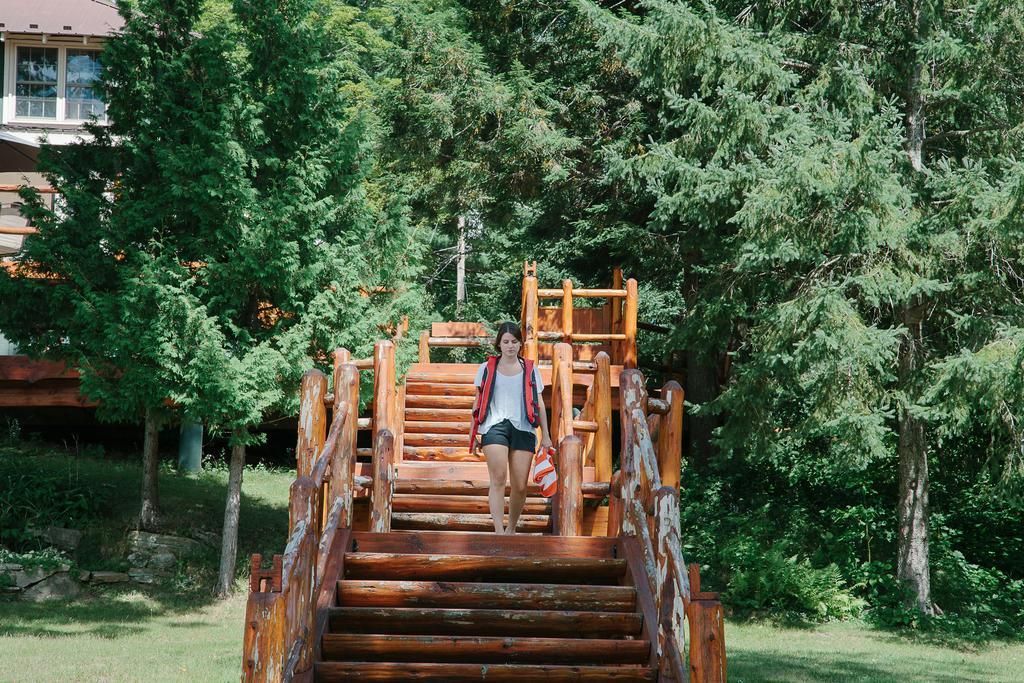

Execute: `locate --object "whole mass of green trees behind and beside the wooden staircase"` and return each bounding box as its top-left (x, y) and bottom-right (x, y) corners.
top-left (0, 0), bottom-right (1024, 638)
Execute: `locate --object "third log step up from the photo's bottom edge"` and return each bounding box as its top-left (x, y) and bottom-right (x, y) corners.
top-left (328, 607), bottom-right (643, 638)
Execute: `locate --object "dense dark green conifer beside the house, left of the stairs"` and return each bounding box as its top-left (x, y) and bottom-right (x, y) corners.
top-left (0, 0), bottom-right (428, 595)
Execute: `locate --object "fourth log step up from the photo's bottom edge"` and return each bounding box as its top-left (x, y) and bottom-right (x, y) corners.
top-left (338, 579), bottom-right (636, 610)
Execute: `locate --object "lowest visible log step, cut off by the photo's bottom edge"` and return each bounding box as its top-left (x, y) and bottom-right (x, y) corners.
top-left (315, 661), bottom-right (654, 683)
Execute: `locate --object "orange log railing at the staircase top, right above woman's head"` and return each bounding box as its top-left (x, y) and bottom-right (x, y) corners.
top-left (521, 263), bottom-right (638, 368)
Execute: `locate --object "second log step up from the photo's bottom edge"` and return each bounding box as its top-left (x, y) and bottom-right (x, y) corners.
top-left (322, 633), bottom-right (650, 665)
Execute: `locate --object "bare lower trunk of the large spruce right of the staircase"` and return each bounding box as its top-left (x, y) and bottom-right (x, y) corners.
top-left (896, 309), bottom-right (934, 614)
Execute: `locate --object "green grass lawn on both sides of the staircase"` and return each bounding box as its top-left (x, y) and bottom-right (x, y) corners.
top-left (0, 445), bottom-right (1024, 683)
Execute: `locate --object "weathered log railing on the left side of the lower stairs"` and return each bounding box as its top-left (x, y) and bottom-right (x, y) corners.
top-left (243, 349), bottom-right (373, 681)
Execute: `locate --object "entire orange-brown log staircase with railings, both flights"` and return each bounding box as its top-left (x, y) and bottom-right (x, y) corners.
top-left (242, 266), bottom-right (726, 681)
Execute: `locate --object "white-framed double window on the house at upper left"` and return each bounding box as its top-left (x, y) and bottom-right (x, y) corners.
top-left (3, 41), bottom-right (106, 124)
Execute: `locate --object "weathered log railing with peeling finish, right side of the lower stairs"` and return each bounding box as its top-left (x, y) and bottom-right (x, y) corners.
top-left (608, 370), bottom-right (725, 682)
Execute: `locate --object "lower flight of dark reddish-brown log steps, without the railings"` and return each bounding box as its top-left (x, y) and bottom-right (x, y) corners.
top-left (313, 531), bottom-right (655, 681)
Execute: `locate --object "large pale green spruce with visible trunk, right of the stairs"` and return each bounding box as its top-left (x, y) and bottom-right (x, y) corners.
top-left (592, 0), bottom-right (1024, 612)
